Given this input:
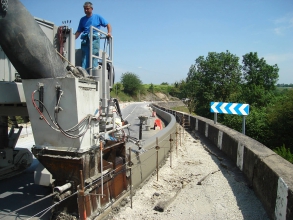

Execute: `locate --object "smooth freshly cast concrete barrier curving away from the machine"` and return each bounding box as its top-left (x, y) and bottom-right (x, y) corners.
top-left (131, 107), bottom-right (177, 188)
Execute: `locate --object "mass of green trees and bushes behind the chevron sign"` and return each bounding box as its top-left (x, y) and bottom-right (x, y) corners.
top-left (174, 51), bottom-right (293, 162)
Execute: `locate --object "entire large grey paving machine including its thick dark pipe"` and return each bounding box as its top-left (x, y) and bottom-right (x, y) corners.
top-left (0, 0), bottom-right (129, 219)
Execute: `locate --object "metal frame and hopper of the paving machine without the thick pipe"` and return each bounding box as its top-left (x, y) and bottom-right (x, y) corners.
top-left (0, 1), bottom-right (129, 219)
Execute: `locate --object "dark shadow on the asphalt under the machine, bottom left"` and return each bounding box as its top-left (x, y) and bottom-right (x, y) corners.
top-left (0, 159), bottom-right (52, 220)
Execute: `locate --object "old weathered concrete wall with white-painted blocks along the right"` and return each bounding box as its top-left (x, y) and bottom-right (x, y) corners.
top-left (157, 103), bottom-right (293, 220)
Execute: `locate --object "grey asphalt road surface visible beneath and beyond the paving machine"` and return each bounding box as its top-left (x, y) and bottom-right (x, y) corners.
top-left (0, 102), bottom-right (157, 220)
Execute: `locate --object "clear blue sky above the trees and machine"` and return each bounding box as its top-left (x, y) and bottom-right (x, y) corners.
top-left (20, 0), bottom-right (293, 85)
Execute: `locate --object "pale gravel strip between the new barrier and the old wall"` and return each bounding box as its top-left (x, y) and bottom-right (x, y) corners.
top-left (106, 129), bottom-right (268, 220)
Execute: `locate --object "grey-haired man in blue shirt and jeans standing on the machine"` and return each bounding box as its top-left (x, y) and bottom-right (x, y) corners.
top-left (75, 2), bottom-right (112, 72)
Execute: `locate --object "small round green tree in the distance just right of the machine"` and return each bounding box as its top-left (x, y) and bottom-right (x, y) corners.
top-left (120, 72), bottom-right (142, 95)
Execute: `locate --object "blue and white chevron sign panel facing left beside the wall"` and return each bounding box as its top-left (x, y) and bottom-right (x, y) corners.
top-left (211, 102), bottom-right (249, 115)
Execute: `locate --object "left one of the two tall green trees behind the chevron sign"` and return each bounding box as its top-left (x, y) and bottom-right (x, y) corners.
top-left (186, 51), bottom-right (241, 117)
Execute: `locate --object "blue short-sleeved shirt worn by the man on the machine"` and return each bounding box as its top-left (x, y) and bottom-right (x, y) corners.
top-left (77, 14), bottom-right (108, 34)
